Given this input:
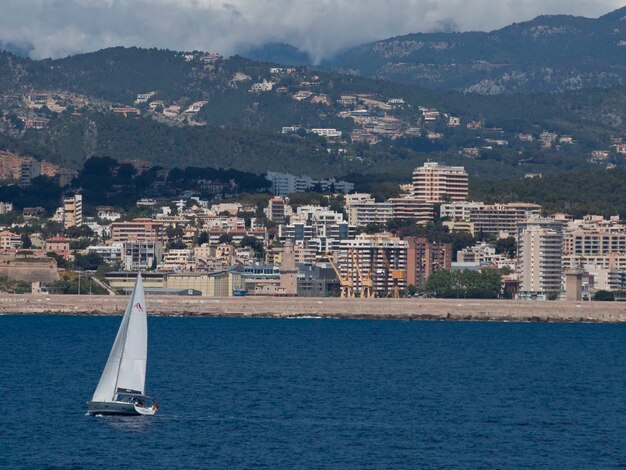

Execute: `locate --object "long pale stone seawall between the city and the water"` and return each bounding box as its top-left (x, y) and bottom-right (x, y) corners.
top-left (0, 294), bottom-right (626, 323)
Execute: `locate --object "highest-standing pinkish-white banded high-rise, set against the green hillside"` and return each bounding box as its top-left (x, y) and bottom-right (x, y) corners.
top-left (413, 162), bottom-right (469, 202)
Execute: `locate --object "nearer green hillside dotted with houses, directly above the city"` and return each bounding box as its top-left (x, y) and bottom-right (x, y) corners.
top-left (0, 47), bottom-right (626, 178)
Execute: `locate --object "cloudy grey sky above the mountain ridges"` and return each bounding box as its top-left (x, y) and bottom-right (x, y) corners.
top-left (0, 0), bottom-right (626, 59)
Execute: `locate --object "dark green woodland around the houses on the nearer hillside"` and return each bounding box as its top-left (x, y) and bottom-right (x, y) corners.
top-left (0, 48), bottom-right (626, 182)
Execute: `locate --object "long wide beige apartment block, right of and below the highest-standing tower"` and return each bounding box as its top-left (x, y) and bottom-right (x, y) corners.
top-left (440, 201), bottom-right (541, 238)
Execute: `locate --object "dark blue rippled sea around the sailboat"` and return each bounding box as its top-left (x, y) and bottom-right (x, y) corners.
top-left (0, 316), bottom-right (626, 469)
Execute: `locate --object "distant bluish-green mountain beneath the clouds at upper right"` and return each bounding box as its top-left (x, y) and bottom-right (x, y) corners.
top-left (323, 7), bottom-right (626, 94)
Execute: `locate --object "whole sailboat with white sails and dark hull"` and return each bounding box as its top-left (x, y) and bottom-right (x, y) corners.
top-left (87, 273), bottom-right (158, 416)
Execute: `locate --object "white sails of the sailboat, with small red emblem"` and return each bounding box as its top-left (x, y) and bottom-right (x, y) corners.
top-left (92, 274), bottom-right (148, 402)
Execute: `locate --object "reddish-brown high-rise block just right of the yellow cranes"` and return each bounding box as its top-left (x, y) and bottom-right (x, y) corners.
top-left (405, 237), bottom-right (452, 289)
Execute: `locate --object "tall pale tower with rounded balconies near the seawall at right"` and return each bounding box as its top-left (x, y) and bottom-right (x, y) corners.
top-left (517, 219), bottom-right (563, 296)
